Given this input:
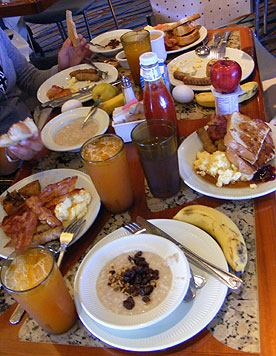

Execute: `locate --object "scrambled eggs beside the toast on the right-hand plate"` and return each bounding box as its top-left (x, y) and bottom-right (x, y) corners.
top-left (194, 151), bottom-right (253, 188)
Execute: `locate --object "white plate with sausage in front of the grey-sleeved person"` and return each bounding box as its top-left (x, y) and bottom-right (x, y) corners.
top-left (37, 62), bottom-right (118, 103)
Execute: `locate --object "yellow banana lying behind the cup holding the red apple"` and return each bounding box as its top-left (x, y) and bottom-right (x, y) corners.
top-left (195, 82), bottom-right (258, 108)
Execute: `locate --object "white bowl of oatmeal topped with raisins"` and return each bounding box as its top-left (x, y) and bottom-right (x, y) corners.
top-left (75, 234), bottom-right (190, 330)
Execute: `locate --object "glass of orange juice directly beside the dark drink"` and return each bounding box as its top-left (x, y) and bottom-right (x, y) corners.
top-left (81, 134), bottom-right (133, 213)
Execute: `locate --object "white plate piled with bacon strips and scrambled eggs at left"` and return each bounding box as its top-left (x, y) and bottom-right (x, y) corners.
top-left (0, 169), bottom-right (101, 258)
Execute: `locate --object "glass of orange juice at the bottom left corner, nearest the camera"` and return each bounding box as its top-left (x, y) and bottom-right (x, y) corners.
top-left (0, 246), bottom-right (77, 334)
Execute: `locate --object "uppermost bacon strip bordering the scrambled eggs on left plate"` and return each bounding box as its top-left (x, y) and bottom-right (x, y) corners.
top-left (39, 176), bottom-right (78, 204)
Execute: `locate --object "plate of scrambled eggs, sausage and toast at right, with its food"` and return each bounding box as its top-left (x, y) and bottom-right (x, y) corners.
top-left (178, 112), bottom-right (276, 200)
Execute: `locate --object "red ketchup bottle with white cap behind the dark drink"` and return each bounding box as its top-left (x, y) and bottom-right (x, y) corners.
top-left (139, 52), bottom-right (179, 138)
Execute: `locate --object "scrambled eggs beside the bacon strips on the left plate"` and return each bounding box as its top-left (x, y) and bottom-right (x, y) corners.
top-left (55, 189), bottom-right (91, 227)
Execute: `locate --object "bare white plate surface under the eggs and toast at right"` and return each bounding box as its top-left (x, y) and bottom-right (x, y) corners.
top-left (178, 124), bottom-right (276, 200)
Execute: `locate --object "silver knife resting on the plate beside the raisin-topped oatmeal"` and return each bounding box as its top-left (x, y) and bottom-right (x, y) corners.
top-left (136, 216), bottom-right (243, 290)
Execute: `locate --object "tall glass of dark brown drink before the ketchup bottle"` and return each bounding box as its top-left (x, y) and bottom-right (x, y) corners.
top-left (131, 119), bottom-right (180, 198)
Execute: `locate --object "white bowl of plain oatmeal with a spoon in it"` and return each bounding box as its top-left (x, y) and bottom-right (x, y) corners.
top-left (41, 107), bottom-right (109, 152)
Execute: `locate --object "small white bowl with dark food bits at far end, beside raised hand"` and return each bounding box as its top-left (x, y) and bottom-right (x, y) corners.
top-left (90, 29), bottom-right (131, 57)
